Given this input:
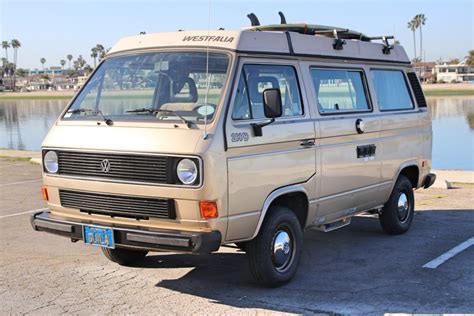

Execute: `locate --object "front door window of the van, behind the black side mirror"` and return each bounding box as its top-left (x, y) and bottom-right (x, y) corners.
top-left (232, 65), bottom-right (303, 120)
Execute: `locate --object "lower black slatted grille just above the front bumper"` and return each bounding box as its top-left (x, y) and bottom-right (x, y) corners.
top-left (59, 190), bottom-right (176, 219)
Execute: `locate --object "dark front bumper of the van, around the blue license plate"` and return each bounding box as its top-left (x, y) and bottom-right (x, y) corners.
top-left (31, 211), bottom-right (221, 253)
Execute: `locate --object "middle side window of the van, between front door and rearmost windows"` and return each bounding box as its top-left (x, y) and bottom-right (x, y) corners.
top-left (311, 68), bottom-right (370, 113)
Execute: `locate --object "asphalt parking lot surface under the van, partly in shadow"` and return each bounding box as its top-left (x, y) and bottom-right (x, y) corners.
top-left (0, 159), bottom-right (474, 315)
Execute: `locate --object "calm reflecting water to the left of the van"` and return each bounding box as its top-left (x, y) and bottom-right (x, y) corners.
top-left (0, 100), bottom-right (68, 150)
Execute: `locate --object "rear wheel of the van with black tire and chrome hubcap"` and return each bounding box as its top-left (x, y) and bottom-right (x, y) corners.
top-left (379, 175), bottom-right (415, 235)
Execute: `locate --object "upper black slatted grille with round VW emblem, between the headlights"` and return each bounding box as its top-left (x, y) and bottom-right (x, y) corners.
top-left (57, 151), bottom-right (171, 184)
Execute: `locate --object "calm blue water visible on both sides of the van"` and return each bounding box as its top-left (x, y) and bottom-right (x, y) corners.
top-left (0, 96), bottom-right (474, 170)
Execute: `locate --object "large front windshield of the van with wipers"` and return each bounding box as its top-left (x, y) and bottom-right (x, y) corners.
top-left (64, 52), bottom-right (229, 123)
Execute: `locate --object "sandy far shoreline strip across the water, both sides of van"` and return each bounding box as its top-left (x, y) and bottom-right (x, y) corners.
top-left (0, 83), bottom-right (474, 100)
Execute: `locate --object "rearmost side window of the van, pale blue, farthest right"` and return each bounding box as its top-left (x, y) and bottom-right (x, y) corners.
top-left (370, 70), bottom-right (414, 111)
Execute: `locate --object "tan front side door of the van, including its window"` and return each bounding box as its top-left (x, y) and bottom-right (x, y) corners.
top-left (226, 59), bottom-right (316, 240)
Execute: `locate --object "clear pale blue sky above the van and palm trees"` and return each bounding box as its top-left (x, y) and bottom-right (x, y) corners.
top-left (0, 0), bottom-right (474, 69)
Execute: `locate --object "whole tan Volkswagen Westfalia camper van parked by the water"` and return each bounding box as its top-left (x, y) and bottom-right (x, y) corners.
top-left (31, 17), bottom-right (435, 286)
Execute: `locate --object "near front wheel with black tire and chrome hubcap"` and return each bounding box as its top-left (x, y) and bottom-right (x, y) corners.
top-left (246, 206), bottom-right (303, 287)
